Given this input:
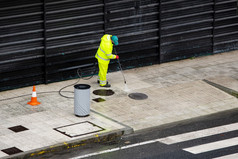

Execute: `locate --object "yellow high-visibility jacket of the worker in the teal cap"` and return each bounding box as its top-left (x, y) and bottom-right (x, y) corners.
top-left (95, 34), bottom-right (116, 64)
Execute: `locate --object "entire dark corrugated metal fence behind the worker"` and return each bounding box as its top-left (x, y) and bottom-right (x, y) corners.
top-left (0, 0), bottom-right (238, 91)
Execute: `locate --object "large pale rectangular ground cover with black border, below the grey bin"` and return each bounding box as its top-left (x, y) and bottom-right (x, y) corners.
top-left (54, 121), bottom-right (105, 137)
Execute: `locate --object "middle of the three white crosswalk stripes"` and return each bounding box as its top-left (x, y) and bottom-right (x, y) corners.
top-left (183, 137), bottom-right (238, 154)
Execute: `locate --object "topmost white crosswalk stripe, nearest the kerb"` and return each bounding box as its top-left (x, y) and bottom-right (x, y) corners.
top-left (158, 123), bottom-right (238, 145)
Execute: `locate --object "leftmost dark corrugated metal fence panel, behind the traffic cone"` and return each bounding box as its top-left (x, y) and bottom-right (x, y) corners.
top-left (0, 0), bottom-right (44, 90)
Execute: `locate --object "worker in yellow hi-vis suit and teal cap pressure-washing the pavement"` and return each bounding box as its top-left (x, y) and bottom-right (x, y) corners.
top-left (95, 34), bottom-right (119, 87)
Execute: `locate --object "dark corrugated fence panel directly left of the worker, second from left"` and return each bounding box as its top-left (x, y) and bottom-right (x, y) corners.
top-left (45, 0), bottom-right (104, 83)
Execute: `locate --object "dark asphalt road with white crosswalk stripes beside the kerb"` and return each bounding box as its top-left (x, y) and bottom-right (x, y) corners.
top-left (38, 109), bottom-right (238, 159)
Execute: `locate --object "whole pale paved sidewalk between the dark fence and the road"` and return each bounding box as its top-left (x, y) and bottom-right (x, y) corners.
top-left (0, 51), bottom-right (238, 158)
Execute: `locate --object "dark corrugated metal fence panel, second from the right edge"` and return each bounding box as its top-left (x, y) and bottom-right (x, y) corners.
top-left (160, 0), bottom-right (214, 62)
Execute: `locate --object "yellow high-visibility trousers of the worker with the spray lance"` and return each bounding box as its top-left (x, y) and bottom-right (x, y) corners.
top-left (98, 62), bottom-right (108, 86)
